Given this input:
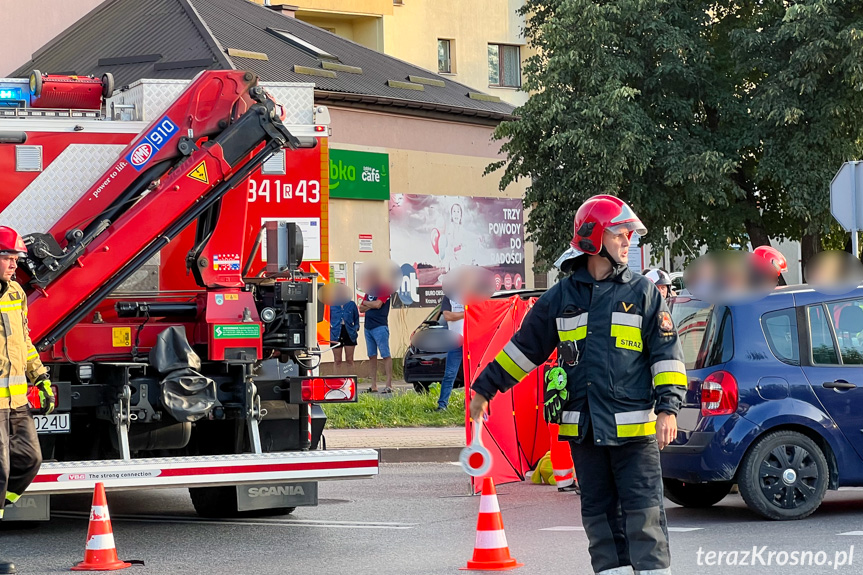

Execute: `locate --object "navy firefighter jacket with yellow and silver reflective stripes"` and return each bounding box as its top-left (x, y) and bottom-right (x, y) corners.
top-left (472, 256), bottom-right (687, 445)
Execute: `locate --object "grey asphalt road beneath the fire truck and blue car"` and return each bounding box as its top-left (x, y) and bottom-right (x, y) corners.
top-left (5, 464), bottom-right (863, 575)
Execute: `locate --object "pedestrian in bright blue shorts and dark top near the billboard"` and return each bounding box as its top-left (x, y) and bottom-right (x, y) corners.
top-left (360, 271), bottom-right (393, 393)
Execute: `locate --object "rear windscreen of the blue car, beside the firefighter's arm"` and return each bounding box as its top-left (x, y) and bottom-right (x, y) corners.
top-left (671, 296), bottom-right (734, 369)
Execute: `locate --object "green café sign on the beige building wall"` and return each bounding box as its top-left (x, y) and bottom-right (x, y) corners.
top-left (330, 149), bottom-right (390, 200)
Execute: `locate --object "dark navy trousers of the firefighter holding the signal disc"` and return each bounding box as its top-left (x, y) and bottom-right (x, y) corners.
top-left (571, 429), bottom-right (671, 575)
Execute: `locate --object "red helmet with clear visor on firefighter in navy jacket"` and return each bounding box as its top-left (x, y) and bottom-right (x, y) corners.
top-left (570, 196), bottom-right (647, 255)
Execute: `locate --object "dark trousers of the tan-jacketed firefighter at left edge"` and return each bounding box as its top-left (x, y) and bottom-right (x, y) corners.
top-left (0, 405), bottom-right (42, 518)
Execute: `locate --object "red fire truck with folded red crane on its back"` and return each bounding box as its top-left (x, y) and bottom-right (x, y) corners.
top-left (0, 71), bottom-right (378, 519)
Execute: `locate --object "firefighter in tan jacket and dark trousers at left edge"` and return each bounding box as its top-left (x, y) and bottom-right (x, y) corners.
top-left (0, 226), bottom-right (54, 573)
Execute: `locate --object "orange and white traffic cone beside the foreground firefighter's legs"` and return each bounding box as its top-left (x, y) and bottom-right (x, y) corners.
top-left (461, 477), bottom-right (523, 571)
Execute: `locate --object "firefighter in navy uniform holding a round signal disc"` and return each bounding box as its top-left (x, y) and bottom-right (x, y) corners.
top-left (470, 196), bottom-right (687, 575)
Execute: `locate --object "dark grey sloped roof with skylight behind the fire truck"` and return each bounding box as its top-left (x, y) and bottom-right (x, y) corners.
top-left (15, 0), bottom-right (514, 120)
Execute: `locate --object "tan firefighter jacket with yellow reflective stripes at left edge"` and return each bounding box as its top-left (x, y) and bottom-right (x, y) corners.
top-left (0, 282), bottom-right (48, 409)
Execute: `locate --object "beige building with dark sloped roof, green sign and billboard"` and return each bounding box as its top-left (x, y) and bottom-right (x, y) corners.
top-left (11, 0), bottom-right (534, 368)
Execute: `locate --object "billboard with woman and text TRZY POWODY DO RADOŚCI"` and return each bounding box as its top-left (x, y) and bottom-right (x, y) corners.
top-left (389, 194), bottom-right (525, 307)
